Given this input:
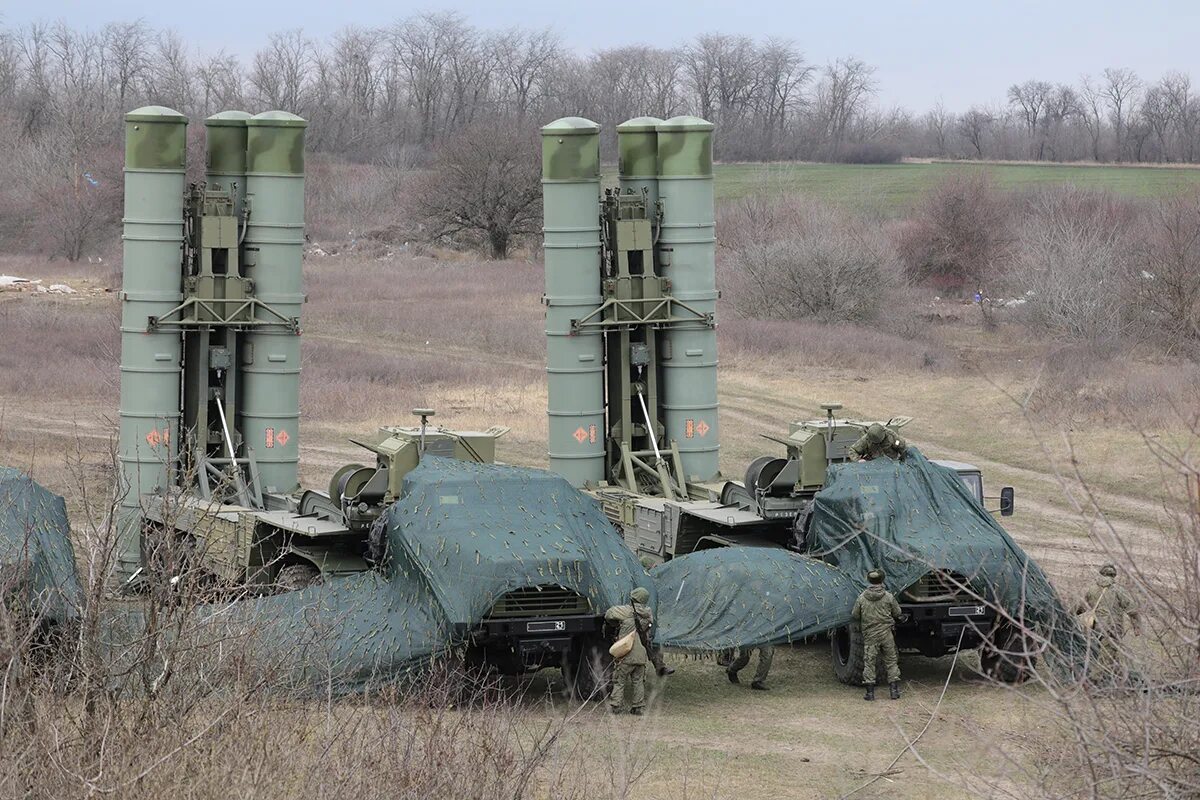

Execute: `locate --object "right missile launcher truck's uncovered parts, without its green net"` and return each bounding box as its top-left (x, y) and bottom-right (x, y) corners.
top-left (541, 116), bottom-right (1027, 675)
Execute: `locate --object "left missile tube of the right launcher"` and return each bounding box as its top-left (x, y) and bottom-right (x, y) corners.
top-left (541, 116), bottom-right (605, 487)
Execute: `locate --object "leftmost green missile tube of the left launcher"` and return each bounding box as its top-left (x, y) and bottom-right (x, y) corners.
top-left (114, 106), bottom-right (187, 581)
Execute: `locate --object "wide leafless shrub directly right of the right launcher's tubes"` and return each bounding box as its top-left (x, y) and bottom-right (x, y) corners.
top-left (725, 196), bottom-right (904, 323)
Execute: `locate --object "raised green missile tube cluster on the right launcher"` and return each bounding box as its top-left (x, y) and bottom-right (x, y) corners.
top-left (541, 116), bottom-right (720, 498)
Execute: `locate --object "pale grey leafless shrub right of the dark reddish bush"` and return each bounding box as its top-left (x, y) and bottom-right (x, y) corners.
top-left (1010, 187), bottom-right (1136, 342)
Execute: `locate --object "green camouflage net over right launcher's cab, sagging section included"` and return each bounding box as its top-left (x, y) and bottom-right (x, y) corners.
top-left (652, 447), bottom-right (1085, 672)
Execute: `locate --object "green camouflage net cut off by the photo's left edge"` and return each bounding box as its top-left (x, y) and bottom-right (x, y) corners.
top-left (0, 467), bottom-right (83, 622)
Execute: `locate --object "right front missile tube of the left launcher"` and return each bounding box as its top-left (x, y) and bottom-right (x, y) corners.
top-left (239, 112), bottom-right (307, 492)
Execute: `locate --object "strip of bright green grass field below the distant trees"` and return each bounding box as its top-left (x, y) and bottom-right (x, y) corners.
top-left (716, 162), bottom-right (1200, 209)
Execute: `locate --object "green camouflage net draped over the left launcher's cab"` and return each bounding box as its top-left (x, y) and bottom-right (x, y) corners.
top-left (211, 456), bottom-right (653, 691)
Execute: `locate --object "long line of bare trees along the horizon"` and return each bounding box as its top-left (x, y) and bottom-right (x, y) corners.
top-left (0, 12), bottom-right (1200, 163)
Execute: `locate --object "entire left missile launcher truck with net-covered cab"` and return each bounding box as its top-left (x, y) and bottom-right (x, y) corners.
top-left (115, 107), bottom-right (646, 697)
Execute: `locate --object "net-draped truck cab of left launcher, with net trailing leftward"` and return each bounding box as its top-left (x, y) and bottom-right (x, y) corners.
top-left (174, 455), bottom-right (653, 698)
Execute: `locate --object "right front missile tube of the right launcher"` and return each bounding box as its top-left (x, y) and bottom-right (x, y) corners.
top-left (658, 116), bottom-right (720, 481)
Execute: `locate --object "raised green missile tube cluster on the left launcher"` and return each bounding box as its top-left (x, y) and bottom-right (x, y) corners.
top-left (114, 106), bottom-right (306, 581)
